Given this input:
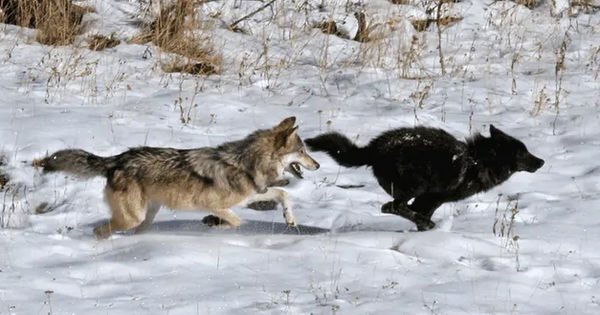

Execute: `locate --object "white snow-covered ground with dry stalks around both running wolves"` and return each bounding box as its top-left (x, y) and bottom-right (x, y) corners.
top-left (0, 0), bottom-right (600, 315)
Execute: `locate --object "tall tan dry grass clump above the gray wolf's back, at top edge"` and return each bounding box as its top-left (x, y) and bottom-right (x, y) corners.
top-left (130, 0), bottom-right (222, 74)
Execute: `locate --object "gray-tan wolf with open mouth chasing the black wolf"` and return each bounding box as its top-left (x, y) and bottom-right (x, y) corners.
top-left (32, 116), bottom-right (319, 239)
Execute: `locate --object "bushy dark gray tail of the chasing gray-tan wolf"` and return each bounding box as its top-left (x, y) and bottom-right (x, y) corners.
top-left (32, 149), bottom-right (109, 178)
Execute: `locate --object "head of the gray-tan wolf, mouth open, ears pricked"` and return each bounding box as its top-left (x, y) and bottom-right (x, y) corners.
top-left (273, 116), bottom-right (319, 178)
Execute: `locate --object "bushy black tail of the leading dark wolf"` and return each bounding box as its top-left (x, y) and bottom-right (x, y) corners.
top-left (304, 132), bottom-right (371, 167)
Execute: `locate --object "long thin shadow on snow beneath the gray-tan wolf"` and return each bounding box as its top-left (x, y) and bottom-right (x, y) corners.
top-left (86, 219), bottom-right (331, 235)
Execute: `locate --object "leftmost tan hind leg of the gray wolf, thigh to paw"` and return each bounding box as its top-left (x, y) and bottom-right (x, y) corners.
top-left (94, 183), bottom-right (147, 239)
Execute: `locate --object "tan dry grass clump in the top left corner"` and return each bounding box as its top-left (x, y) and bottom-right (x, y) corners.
top-left (0, 0), bottom-right (93, 46)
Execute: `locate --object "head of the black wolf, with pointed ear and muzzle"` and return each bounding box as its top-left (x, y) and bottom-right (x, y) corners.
top-left (490, 125), bottom-right (544, 173)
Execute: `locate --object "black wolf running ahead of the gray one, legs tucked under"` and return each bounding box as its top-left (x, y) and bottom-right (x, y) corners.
top-left (304, 125), bottom-right (544, 231)
